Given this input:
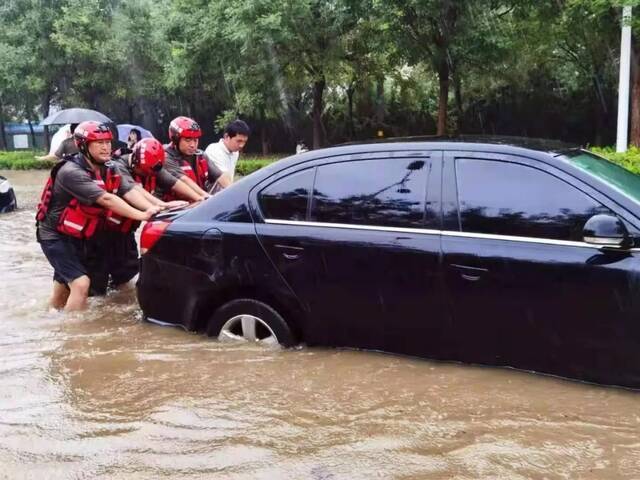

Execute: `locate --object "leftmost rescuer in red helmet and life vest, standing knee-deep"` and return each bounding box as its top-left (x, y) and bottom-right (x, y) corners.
top-left (36, 121), bottom-right (159, 311)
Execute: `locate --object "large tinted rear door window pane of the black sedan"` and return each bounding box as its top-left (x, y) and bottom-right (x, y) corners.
top-left (311, 158), bottom-right (430, 228)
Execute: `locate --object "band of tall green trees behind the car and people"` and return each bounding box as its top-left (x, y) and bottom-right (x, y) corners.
top-left (0, 0), bottom-right (640, 151)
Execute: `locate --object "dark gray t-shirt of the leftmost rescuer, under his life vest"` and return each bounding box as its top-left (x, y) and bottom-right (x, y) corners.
top-left (38, 155), bottom-right (135, 240)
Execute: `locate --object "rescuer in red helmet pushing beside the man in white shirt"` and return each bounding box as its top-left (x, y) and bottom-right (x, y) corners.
top-left (157, 117), bottom-right (231, 200)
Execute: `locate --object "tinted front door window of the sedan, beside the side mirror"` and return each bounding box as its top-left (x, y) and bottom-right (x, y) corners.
top-left (455, 158), bottom-right (613, 241)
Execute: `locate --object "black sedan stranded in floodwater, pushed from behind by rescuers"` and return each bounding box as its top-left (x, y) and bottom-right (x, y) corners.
top-left (138, 138), bottom-right (640, 388)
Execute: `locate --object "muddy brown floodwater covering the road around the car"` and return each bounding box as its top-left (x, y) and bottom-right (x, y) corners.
top-left (0, 171), bottom-right (640, 480)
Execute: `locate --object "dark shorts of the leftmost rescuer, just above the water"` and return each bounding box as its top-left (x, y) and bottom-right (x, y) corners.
top-left (40, 236), bottom-right (108, 295)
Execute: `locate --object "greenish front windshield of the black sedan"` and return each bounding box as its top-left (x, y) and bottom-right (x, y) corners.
top-left (561, 150), bottom-right (640, 204)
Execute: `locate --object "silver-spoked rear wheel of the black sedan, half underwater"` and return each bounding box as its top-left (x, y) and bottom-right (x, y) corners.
top-left (207, 298), bottom-right (295, 347)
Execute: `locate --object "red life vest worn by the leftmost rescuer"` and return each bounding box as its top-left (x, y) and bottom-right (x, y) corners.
top-left (36, 157), bottom-right (120, 239)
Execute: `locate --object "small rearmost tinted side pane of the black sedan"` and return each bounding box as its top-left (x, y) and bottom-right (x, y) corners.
top-left (258, 168), bottom-right (315, 221)
